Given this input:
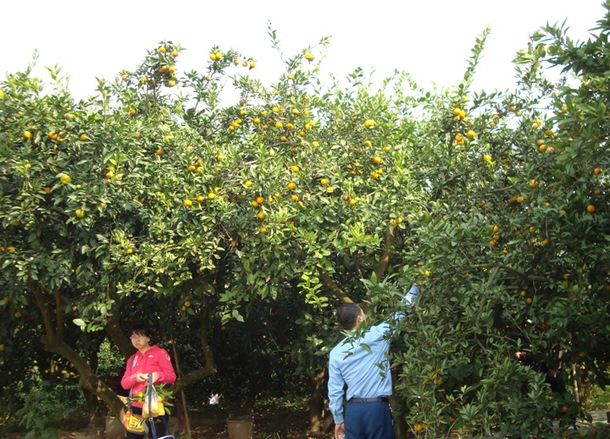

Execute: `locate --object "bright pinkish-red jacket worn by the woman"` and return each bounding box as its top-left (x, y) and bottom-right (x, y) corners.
top-left (121, 345), bottom-right (176, 407)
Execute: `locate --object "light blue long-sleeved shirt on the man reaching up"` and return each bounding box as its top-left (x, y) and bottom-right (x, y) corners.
top-left (328, 285), bottom-right (419, 424)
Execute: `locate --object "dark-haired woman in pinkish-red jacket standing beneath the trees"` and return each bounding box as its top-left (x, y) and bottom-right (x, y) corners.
top-left (121, 324), bottom-right (176, 439)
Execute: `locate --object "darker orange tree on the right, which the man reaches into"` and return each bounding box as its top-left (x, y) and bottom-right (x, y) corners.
top-left (395, 4), bottom-right (610, 437)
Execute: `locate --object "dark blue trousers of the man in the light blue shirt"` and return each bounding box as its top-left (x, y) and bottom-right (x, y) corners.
top-left (345, 400), bottom-right (394, 439)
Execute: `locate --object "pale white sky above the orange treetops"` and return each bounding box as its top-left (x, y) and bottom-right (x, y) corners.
top-left (0, 0), bottom-right (604, 97)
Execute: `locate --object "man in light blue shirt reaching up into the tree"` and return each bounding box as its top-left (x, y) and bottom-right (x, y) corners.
top-left (328, 285), bottom-right (419, 439)
